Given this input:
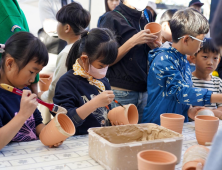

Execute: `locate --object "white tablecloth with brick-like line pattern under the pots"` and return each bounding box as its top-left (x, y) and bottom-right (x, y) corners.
top-left (0, 121), bottom-right (222, 170)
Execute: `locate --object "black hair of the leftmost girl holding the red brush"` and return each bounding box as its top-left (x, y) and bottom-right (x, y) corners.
top-left (0, 32), bottom-right (48, 71)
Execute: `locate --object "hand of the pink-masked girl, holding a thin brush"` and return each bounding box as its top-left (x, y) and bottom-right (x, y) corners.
top-left (93, 90), bottom-right (115, 108)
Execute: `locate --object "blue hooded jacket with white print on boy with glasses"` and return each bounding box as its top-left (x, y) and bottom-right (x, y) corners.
top-left (143, 47), bottom-right (212, 124)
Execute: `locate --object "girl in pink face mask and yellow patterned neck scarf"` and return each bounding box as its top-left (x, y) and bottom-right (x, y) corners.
top-left (53, 28), bottom-right (118, 135)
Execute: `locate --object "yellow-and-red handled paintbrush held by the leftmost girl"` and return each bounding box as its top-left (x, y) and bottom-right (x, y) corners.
top-left (0, 83), bottom-right (67, 114)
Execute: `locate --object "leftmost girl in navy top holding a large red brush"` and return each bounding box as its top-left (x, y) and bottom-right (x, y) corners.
top-left (0, 32), bottom-right (62, 150)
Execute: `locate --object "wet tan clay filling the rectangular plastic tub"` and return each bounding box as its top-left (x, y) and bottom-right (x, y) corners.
top-left (94, 124), bottom-right (182, 144)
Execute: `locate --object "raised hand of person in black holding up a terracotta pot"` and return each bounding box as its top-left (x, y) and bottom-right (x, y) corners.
top-left (131, 29), bottom-right (157, 45)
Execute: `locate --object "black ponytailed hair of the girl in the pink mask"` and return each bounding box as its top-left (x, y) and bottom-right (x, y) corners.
top-left (66, 28), bottom-right (118, 71)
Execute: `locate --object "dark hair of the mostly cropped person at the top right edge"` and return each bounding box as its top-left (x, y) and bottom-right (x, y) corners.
top-left (210, 1), bottom-right (222, 47)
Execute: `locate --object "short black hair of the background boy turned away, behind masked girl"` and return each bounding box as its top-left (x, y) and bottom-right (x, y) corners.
top-left (56, 2), bottom-right (91, 35)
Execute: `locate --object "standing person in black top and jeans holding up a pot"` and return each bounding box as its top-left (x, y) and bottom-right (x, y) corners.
top-left (99, 0), bottom-right (160, 123)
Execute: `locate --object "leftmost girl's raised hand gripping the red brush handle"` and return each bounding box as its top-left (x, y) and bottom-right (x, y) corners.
top-left (19, 90), bottom-right (38, 119)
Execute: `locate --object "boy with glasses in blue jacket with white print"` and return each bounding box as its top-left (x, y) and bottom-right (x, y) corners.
top-left (143, 8), bottom-right (222, 124)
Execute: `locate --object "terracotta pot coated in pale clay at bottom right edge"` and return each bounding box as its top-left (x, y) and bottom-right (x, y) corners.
top-left (182, 145), bottom-right (210, 170)
